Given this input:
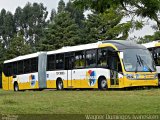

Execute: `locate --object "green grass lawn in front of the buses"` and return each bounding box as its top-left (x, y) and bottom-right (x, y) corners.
top-left (0, 89), bottom-right (160, 114)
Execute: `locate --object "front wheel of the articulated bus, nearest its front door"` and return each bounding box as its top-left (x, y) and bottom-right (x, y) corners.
top-left (98, 77), bottom-right (108, 90)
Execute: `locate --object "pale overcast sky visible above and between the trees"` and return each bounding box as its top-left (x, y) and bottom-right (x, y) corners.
top-left (0, 0), bottom-right (155, 38)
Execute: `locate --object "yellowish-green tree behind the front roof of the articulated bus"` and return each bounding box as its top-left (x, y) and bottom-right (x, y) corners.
top-left (85, 8), bottom-right (142, 42)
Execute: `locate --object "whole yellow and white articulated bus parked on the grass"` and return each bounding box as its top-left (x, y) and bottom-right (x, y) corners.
top-left (2, 40), bottom-right (158, 91)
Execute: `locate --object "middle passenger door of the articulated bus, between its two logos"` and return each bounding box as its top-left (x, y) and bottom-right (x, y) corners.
top-left (65, 54), bottom-right (74, 88)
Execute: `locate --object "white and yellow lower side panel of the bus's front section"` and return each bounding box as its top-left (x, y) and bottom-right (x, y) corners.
top-left (47, 68), bottom-right (110, 88)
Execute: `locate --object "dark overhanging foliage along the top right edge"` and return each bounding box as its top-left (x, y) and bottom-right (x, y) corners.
top-left (72, 0), bottom-right (160, 30)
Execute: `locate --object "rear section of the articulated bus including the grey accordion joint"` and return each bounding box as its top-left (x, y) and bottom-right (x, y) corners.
top-left (2, 52), bottom-right (47, 91)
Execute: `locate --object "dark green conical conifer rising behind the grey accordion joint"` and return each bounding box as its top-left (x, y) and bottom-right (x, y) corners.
top-left (41, 12), bottom-right (80, 50)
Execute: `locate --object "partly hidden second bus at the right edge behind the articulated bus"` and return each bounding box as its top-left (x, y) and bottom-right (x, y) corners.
top-left (142, 40), bottom-right (160, 85)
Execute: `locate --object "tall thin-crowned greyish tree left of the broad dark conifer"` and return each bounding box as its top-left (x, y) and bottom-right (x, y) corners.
top-left (15, 3), bottom-right (48, 52)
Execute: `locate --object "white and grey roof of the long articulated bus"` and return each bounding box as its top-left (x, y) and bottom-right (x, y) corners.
top-left (4, 40), bottom-right (146, 63)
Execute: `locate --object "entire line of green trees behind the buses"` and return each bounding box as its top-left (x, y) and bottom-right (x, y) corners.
top-left (0, 0), bottom-right (160, 64)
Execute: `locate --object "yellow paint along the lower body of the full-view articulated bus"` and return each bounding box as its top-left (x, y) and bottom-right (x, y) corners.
top-left (2, 72), bottom-right (158, 90)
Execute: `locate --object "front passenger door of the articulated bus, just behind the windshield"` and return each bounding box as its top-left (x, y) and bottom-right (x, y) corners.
top-left (108, 51), bottom-right (120, 86)
